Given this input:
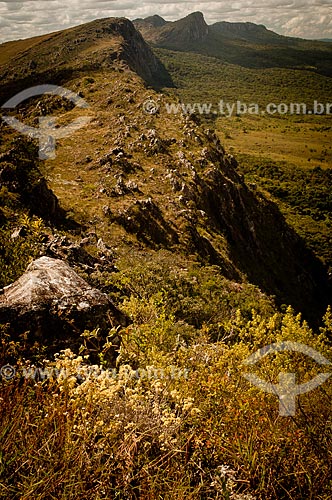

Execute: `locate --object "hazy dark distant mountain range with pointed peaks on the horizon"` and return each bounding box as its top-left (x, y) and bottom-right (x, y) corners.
top-left (136, 12), bottom-right (332, 76)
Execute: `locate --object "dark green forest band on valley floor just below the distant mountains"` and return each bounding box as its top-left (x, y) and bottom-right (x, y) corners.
top-left (154, 48), bottom-right (332, 106)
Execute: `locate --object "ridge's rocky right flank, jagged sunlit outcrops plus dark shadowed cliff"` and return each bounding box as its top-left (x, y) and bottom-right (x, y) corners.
top-left (105, 114), bottom-right (330, 324)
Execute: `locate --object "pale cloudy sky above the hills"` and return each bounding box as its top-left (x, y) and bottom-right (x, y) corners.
top-left (0, 0), bottom-right (332, 41)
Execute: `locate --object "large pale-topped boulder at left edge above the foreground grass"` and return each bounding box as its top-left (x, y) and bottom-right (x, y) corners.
top-left (0, 257), bottom-right (127, 364)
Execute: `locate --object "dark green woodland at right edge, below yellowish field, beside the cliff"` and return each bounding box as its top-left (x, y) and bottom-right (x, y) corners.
top-left (237, 155), bottom-right (332, 269)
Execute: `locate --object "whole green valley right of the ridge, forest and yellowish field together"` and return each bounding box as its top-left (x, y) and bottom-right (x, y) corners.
top-left (155, 49), bottom-right (332, 266)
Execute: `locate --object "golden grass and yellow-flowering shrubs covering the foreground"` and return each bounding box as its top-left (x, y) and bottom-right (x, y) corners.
top-left (0, 255), bottom-right (332, 500)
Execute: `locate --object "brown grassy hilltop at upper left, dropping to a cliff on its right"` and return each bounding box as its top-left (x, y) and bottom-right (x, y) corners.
top-left (0, 18), bottom-right (172, 100)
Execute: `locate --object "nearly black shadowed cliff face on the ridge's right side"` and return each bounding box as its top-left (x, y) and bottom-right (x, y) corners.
top-left (194, 164), bottom-right (329, 320)
